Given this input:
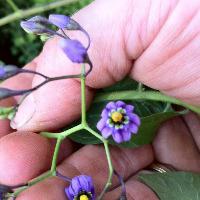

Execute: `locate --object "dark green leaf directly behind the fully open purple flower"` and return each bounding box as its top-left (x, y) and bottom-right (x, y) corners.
top-left (70, 79), bottom-right (184, 147)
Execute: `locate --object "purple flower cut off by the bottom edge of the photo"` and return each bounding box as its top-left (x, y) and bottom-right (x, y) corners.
top-left (65, 175), bottom-right (95, 200)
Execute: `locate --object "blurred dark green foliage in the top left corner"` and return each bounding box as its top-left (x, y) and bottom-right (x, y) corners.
top-left (0, 0), bottom-right (92, 67)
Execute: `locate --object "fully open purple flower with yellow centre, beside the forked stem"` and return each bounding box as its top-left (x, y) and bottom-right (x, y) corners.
top-left (97, 101), bottom-right (140, 143)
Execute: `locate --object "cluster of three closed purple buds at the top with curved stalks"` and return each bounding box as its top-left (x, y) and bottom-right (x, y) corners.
top-left (21, 14), bottom-right (91, 65)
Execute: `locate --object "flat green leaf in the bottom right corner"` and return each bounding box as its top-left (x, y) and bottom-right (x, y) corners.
top-left (139, 172), bottom-right (200, 200)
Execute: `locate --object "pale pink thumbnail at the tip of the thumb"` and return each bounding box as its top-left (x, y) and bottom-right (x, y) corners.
top-left (10, 94), bottom-right (36, 129)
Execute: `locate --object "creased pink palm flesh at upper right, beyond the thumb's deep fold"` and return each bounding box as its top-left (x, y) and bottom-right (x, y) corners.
top-left (132, 0), bottom-right (200, 105)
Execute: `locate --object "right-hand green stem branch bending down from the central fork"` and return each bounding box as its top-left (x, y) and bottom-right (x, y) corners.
top-left (85, 126), bottom-right (114, 200)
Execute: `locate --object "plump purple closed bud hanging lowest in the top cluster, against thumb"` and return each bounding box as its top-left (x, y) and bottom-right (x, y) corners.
top-left (60, 39), bottom-right (87, 63)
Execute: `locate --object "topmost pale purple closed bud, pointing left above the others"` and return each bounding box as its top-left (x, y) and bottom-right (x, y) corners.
top-left (49, 14), bottom-right (70, 28)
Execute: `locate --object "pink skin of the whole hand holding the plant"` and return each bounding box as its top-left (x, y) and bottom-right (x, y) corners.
top-left (0, 0), bottom-right (200, 200)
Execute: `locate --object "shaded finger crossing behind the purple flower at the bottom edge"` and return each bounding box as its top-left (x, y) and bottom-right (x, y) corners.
top-left (18, 145), bottom-right (153, 200)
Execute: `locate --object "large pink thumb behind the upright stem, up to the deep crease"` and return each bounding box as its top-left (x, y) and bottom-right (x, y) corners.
top-left (12, 0), bottom-right (183, 131)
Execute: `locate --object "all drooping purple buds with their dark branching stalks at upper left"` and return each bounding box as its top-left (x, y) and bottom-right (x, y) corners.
top-left (0, 14), bottom-right (92, 106)
